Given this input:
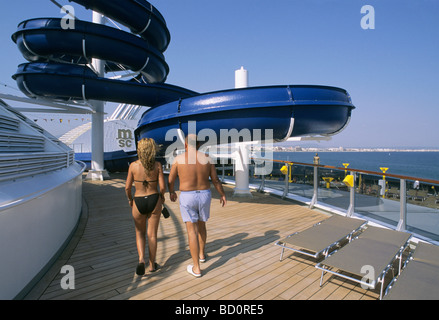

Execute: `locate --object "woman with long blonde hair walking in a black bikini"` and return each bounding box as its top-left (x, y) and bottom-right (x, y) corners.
top-left (125, 138), bottom-right (166, 275)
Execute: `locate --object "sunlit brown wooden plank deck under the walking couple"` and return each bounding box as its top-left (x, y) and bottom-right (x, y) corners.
top-left (26, 174), bottom-right (378, 300)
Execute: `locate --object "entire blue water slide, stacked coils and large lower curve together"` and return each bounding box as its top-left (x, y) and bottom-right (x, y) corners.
top-left (12, 0), bottom-right (355, 156)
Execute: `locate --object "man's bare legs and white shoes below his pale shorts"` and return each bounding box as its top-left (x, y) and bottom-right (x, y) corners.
top-left (186, 221), bottom-right (207, 274)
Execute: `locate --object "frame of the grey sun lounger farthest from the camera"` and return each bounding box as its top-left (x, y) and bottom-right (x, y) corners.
top-left (275, 216), bottom-right (367, 261)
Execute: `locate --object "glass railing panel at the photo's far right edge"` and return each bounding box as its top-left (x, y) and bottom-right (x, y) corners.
top-left (406, 180), bottom-right (439, 241)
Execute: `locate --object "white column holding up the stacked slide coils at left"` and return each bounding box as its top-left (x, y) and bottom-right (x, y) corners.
top-left (86, 11), bottom-right (109, 180)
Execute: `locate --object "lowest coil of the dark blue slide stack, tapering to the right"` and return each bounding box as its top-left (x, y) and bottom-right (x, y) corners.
top-left (13, 62), bottom-right (196, 106)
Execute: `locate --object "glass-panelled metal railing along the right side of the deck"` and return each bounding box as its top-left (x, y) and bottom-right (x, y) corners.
top-left (217, 159), bottom-right (439, 243)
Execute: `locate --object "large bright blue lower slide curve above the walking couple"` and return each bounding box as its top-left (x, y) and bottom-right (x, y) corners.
top-left (135, 85), bottom-right (355, 151)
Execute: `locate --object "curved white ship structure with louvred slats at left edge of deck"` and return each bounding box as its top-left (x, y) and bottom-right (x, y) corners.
top-left (0, 100), bottom-right (85, 299)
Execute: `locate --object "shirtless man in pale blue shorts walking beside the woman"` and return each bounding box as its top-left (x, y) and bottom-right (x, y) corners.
top-left (169, 134), bottom-right (227, 277)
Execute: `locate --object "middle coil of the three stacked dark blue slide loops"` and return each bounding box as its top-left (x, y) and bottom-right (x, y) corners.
top-left (12, 18), bottom-right (169, 83)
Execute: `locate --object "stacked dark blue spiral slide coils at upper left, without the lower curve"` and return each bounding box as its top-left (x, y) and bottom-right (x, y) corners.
top-left (12, 0), bottom-right (197, 107)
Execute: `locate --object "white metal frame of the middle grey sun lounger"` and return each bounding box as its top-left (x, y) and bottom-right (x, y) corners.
top-left (315, 227), bottom-right (412, 300)
